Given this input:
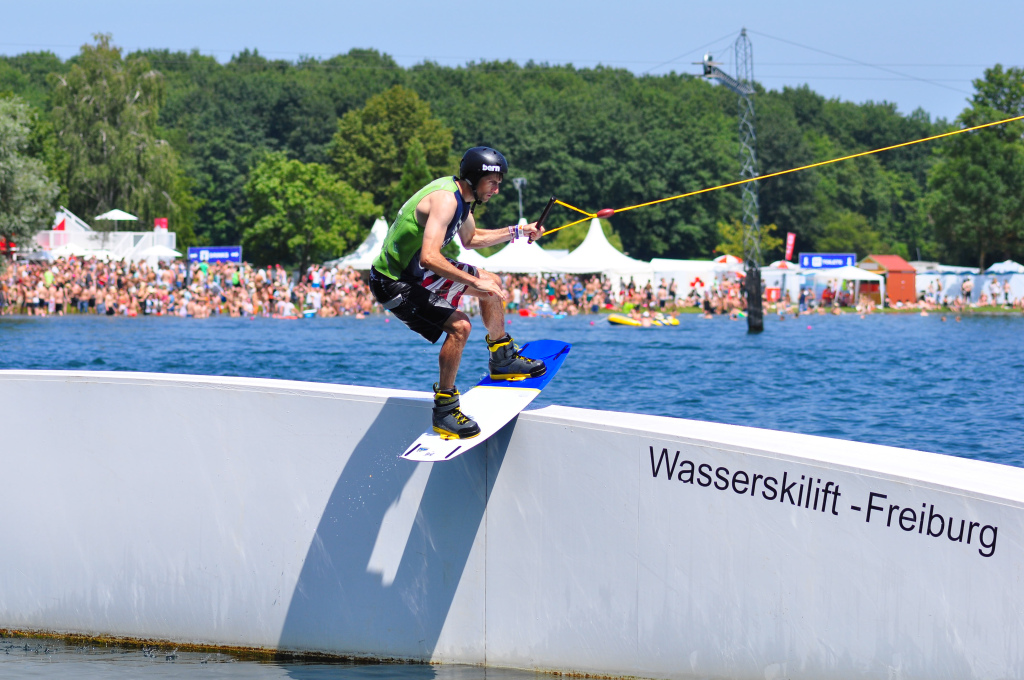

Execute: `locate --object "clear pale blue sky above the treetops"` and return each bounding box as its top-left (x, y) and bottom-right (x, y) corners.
top-left (0, 0), bottom-right (1024, 118)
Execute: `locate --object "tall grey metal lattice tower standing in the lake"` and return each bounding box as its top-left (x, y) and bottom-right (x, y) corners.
top-left (701, 29), bottom-right (764, 333)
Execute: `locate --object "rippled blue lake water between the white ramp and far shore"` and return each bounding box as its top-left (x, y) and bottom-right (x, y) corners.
top-left (0, 314), bottom-right (1024, 466)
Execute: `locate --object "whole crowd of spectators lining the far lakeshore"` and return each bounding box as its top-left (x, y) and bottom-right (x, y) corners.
top-left (0, 257), bottom-right (1024, 318)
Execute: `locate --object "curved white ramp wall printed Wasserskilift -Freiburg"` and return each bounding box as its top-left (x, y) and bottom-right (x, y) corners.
top-left (0, 371), bottom-right (1024, 680)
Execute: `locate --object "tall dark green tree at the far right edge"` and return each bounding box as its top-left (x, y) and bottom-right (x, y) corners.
top-left (929, 66), bottom-right (1024, 270)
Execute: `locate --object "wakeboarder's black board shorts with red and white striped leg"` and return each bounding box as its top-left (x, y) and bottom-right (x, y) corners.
top-left (370, 259), bottom-right (477, 342)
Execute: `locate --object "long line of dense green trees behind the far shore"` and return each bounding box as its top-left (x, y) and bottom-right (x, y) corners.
top-left (0, 35), bottom-right (1024, 266)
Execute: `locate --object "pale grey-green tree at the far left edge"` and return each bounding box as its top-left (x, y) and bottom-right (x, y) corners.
top-left (0, 96), bottom-right (57, 260)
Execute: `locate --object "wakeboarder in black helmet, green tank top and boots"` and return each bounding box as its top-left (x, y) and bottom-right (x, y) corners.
top-left (370, 146), bottom-right (547, 439)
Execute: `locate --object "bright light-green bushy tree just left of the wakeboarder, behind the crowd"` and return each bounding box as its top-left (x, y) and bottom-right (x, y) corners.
top-left (242, 152), bottom-right (380, 271)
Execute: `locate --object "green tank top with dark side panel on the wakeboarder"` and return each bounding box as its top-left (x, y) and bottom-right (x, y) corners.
top-left (374, 176), bottom-right (470, 283)
